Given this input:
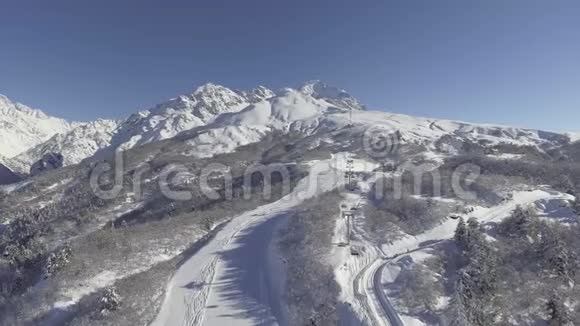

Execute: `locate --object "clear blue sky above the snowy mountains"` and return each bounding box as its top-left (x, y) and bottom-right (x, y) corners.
top-left (0, 0), bottom-right (580, 131)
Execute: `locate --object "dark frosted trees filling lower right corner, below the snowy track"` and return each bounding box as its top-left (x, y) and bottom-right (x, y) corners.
top-left (446, 207), bottom-right (579, 326)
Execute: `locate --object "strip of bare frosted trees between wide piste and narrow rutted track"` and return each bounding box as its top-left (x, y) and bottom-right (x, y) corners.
top-left (280, 191), bottom-right (342, 326)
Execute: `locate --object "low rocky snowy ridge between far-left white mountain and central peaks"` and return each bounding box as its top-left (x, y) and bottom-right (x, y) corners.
top-left (16, 120), bottom-right (119, 167)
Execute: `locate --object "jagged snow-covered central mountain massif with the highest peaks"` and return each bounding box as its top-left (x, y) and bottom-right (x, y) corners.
top-left (101, 81), bottom-right (365, 156)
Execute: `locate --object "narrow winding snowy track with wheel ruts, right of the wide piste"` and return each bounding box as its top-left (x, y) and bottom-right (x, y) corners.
top-left (332, 185), bottom-right (572, 326)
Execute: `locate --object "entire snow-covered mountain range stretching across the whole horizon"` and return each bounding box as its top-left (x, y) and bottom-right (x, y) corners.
top-left (0, 81), bottom-right (570, 177)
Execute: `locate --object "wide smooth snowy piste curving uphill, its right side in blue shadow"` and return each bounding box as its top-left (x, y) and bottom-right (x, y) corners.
top-left (151, 159), bottom-right (344, 326)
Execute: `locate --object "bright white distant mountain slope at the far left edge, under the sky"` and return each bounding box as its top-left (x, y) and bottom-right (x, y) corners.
top-left (0, 95), bottom-right (76, 158)
